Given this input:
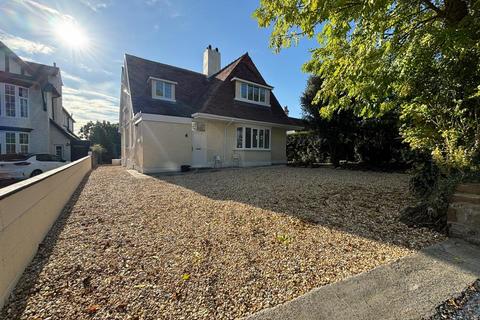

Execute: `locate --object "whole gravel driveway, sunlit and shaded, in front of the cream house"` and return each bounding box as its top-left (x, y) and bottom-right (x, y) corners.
top-left (0, 167), bottom-right (443, 320)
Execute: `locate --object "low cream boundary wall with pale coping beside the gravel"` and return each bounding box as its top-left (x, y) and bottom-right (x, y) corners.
top-left (0, 156), bottom-right (92, 309)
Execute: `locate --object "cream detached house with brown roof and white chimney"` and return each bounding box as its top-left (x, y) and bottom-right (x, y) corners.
top-left (120, 46), bottom-right (301, 173)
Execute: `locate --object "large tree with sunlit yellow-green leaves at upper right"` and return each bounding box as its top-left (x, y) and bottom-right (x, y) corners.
top-left (254, 0), bottom-right (480, 169)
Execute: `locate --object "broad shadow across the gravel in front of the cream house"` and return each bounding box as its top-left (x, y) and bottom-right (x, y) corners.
top-left (154, 166), bottom-right (435, 249)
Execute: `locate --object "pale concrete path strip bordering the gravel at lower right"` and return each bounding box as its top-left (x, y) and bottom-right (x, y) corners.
top-left (247, 239), bottom-right (480, 320)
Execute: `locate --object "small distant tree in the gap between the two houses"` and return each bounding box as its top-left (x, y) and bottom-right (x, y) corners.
top-left (80, 121), bottom-right (120, 163)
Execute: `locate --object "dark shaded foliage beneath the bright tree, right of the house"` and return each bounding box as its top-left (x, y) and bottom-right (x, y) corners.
top-left (296, 76), bottom-right (412, 169)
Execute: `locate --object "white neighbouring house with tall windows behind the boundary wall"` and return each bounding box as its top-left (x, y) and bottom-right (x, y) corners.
top-left (0, 41), bottom-right (84, 160)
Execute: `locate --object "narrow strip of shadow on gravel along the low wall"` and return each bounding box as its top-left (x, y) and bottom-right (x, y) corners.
top-left (0, 171), bottom-right (91, 320)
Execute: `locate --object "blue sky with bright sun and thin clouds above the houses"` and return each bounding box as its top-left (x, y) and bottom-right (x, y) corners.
top-left (0, 0), bottom-right (316, 131)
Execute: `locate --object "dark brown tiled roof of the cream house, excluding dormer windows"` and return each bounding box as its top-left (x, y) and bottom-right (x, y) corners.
top-left (125, 53), bottom-right (298, 125)
